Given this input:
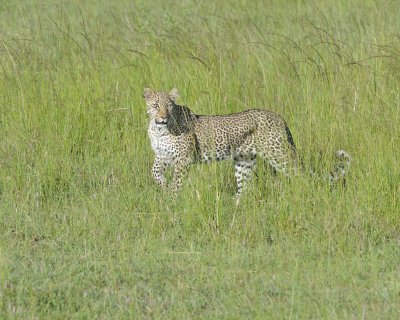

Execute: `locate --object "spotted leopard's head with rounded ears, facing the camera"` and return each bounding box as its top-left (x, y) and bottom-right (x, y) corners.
top-left (143, 88), bottom-right (179, 127)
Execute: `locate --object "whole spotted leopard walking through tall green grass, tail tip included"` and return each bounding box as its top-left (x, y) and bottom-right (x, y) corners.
top-left (143, 88), bottom-right (350, 204)
